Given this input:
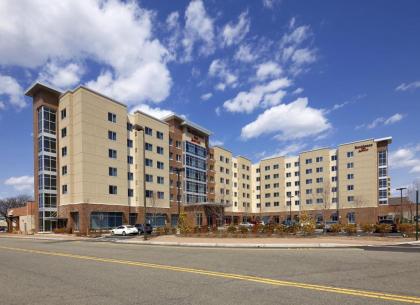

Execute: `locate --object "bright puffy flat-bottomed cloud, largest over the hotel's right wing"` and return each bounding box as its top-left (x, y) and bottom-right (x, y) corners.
top-left (241, 98), bottom-right (331, 141)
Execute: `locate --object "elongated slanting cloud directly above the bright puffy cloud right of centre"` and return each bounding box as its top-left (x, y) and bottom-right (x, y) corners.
top-left (223, 78), bottom-right (291, 113)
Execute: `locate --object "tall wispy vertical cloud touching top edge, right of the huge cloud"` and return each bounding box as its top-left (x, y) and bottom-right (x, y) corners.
top-left (182, 0), bottom-right (214, 61)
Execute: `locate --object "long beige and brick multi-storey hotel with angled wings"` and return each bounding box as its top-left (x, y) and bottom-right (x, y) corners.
top-left (26, 83), bottom-right (391, 232)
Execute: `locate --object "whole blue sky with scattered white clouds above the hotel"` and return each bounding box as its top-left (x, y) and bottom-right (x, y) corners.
top-left (0, 0), bottom-right (420, 198)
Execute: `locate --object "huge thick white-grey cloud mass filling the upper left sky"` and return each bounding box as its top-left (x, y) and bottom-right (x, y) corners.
top-left (0, 0), bottom-right (172, 104)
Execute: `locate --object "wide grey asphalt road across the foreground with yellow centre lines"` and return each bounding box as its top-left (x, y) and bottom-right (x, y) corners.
top-left (0, 238), bottom-right (420, 305)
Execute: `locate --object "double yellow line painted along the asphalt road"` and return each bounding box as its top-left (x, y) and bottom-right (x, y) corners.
top-left (0, 246), bottom-right (420, 304)
